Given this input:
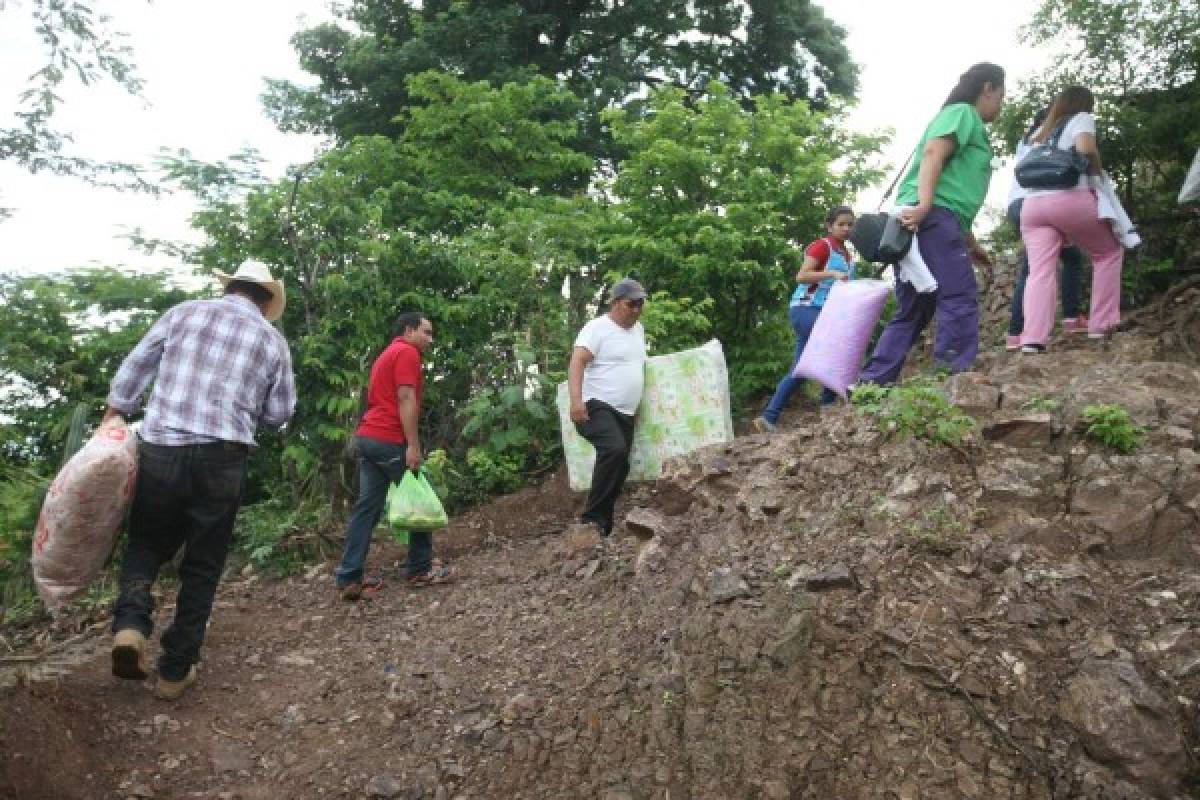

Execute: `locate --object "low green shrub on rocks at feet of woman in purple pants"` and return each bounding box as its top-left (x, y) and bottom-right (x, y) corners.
top-left (851, 379), bottom-right (976, 446)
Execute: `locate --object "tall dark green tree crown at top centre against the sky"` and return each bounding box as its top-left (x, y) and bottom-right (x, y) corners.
top-left (265, 0), bottom-right (857, 151)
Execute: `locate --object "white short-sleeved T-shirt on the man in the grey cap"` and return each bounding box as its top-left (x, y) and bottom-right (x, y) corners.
top-left (575, 314), bottom-right (646, 416)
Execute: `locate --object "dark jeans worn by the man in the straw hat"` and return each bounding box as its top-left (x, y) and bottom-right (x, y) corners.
top-left (113, 441), bottom-right (248, 680)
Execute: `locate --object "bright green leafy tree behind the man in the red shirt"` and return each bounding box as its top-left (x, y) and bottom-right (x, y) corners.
top-left (168, 73), bottom-right (602, 513)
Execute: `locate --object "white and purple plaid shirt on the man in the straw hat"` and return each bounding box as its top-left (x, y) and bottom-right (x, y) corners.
top-left (108, 295), bottom-right (296, 445)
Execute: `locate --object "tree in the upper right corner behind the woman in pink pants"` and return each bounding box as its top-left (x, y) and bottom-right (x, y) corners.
top-left (1000, 0), bottom-right (1200, 272)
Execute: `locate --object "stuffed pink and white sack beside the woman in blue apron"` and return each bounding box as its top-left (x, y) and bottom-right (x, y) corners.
top-left (792, 279), bottom-right (892, 399)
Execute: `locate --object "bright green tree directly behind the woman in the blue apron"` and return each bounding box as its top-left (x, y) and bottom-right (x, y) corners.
top-left (602, 83), bottom-right (880, 401)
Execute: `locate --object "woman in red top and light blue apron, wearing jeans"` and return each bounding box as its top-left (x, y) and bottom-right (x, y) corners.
top-left (754, 205), bottom-right (854, 433)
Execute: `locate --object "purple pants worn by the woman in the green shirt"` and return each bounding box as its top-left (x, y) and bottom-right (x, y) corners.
top-left (862, 205), bottom-right (979, 384)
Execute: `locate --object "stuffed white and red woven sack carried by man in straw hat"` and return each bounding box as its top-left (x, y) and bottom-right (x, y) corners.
top-left (32, 421), bottom-right (138, 610)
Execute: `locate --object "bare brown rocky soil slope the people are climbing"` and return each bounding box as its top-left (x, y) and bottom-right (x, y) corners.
top-left (0, 266), bottom-right (1200, 800)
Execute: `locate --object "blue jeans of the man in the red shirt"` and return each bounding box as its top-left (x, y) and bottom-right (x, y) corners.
top-left (334, 437), bottom-right (433, 588)
